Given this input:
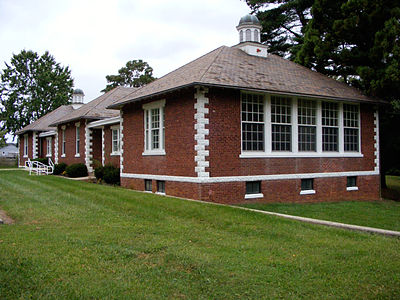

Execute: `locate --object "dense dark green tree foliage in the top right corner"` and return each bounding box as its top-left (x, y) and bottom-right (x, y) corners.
top-left (296, 0), bottom-right (400, 100)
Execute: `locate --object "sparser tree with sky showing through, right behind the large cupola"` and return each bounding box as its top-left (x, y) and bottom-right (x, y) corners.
top-left (246, 0), bottom-right (314, 60)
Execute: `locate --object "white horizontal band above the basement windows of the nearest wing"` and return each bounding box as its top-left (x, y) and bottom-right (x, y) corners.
top-left (121, 171), bottom-right (379, 183)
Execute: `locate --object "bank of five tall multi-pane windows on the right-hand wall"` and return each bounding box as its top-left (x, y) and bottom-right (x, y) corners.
top-left (241, 93), bottom-right (362, 157)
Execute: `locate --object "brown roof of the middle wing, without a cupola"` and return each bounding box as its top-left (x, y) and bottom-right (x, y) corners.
top-left (51, 87), bottom-right (136, 126)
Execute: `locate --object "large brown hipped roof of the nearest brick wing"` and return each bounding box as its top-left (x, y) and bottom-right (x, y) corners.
top-left (109, 46), bottom-right (378, 108)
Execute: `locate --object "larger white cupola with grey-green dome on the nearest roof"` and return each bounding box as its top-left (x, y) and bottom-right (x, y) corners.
top-left (235, 15), bottom-right (268, 57)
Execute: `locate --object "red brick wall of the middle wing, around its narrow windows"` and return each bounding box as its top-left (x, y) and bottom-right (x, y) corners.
top-left (58, 120), bottom-right (85, 165)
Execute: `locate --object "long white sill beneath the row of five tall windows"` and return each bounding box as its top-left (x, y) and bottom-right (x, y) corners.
top-left (239, 152), bottom-right (364, 158)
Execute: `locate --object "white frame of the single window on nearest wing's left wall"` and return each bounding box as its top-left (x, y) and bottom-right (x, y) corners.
top-left (142, 99), bottom-right (165, 155)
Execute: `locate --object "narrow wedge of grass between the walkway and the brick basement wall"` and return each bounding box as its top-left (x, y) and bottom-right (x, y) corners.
top-left (241, 176), bottom-right (400, 231)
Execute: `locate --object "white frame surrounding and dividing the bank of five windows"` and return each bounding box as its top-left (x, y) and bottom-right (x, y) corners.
top-left (239, 91), bottom-right (364, 158)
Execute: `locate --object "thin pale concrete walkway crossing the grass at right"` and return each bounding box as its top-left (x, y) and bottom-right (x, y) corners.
top-left (233, 205), bottom-right (400, 238)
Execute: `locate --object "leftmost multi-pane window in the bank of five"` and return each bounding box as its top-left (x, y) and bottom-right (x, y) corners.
top-left (242, 94), bottom-right (264, 151)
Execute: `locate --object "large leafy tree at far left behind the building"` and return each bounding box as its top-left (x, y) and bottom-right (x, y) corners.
top-left (0, 50), bottom-right (73, 134)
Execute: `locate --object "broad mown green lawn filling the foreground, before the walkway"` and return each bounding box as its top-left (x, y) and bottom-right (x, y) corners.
top-left (0, 171), bottom-right (400, 299)
